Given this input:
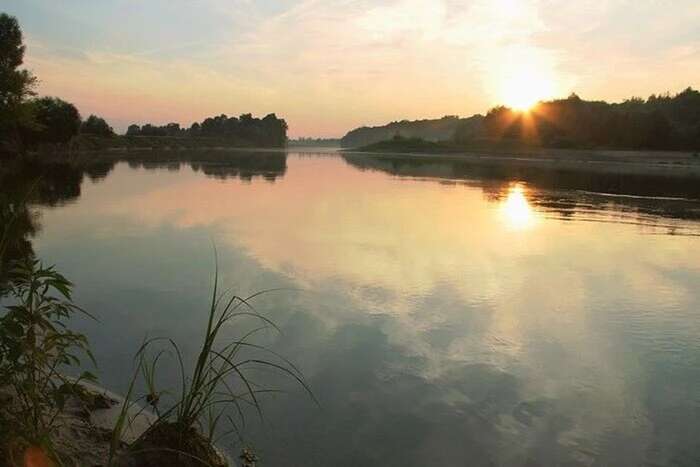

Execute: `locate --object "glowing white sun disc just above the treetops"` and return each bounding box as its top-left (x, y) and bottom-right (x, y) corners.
top-left (500, 63), bottom-right (554, 111)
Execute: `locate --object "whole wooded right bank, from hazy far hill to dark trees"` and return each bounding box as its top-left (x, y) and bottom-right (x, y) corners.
top-left (341, 88), bottom-right (700, 151)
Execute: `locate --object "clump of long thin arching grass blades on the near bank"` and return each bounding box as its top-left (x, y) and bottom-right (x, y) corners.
top-left (110, 262), bottom-right (315, 467)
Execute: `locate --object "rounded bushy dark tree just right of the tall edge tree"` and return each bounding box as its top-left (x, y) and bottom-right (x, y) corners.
top-left (23, 97), bottom-right (80, 146)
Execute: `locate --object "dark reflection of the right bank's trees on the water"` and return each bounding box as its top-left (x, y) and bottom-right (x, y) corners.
top-left (343, 154), bottom-right (700, 233)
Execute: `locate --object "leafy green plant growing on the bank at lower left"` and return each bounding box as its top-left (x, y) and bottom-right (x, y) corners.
top-left (0, 258), bottom-right (95, 456)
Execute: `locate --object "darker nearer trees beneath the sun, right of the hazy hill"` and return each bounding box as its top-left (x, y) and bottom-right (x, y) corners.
top-left (454, 88), bottom-right (700, 150)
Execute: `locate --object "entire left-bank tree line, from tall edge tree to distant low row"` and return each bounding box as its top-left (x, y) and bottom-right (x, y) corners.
top-left (0, 13), bottom-right (287, 154)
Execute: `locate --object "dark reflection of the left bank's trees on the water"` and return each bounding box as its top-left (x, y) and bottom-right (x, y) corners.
top-left (0, 151), bottom-right (287, 280)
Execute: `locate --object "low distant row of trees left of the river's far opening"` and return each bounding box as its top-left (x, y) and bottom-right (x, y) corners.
top-left (126, 114), bottom-right (287, 147)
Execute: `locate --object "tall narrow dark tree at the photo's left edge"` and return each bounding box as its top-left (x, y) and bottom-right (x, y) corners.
top-left (0, 13), bottom-right (36, 151)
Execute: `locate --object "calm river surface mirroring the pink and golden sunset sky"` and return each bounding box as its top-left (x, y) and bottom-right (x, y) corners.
top-left (10, 152), bottom-right (700, 466)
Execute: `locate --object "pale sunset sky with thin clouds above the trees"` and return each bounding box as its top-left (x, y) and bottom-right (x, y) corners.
top-left (0, 0), bottom-right (700, 137)
